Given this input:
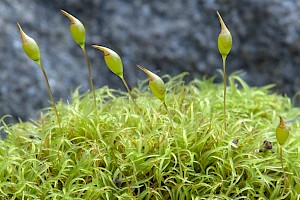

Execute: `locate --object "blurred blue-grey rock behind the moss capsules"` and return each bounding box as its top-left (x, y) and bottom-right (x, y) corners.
top-left (0, 0), bottom-right (300, 125)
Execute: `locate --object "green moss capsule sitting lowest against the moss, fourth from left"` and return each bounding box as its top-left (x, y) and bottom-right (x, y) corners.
top-left (137, 65), bottom-right (166, 101)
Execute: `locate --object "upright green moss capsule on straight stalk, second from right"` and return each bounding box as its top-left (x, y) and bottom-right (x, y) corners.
top-left (217, 11), bottom-right (232, 57)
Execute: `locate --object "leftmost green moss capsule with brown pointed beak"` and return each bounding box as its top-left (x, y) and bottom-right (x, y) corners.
top-left (17, 23), bottom-right (40, 63)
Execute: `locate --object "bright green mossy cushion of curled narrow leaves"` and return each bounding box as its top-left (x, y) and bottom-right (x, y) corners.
top-left (0, 72), bottom-right (300, 200)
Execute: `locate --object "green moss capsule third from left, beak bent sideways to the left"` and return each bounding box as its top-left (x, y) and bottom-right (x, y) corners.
top-left (92, 45), bottom-right (123, 78)
